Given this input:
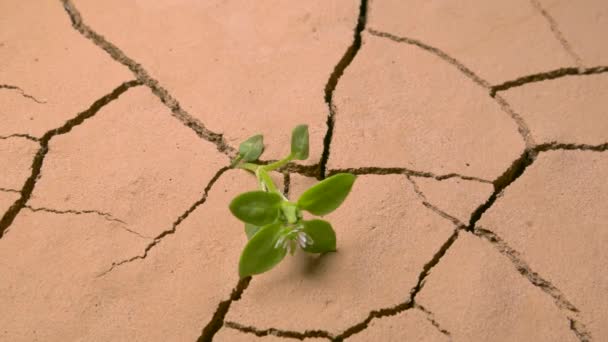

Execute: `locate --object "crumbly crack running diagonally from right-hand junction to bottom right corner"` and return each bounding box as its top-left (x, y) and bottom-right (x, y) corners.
top-left (472, 227), bottom-right (591, 342)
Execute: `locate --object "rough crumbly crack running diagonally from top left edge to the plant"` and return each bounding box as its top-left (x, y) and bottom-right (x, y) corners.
top-left (61, 0), bottom-right (236, 158)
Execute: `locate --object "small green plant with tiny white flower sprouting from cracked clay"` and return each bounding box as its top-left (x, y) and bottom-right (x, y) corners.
top-left (230, 125), bottom-right (355, 278)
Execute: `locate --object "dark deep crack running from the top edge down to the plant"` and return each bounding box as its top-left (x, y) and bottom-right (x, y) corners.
top-left (319, 0), bottom-right (367, 179)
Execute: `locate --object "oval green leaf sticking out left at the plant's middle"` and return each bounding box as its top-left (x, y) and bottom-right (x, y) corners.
top-left (230, 191), bottom-right (281, 226)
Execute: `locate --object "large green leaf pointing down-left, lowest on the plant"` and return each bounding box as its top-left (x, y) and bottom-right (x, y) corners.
top-left (239, 222), bottom-right (287, 278)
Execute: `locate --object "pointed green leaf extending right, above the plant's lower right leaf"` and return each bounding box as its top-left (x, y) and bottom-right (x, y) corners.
top-left (298, 173), bottom-right (356, 216)
